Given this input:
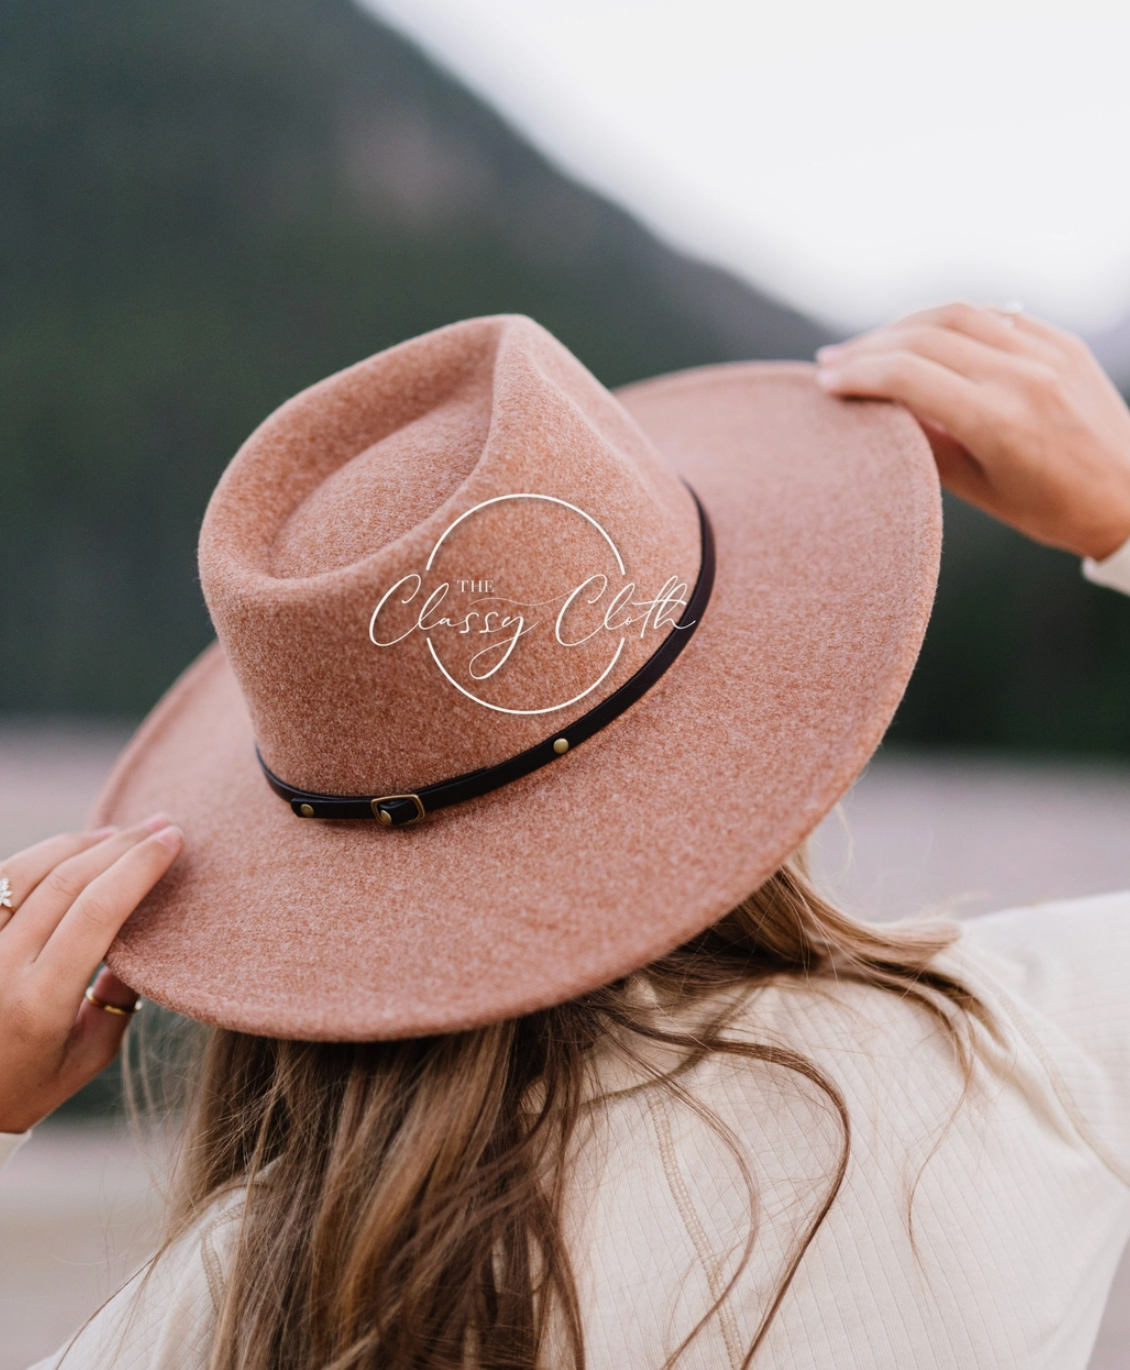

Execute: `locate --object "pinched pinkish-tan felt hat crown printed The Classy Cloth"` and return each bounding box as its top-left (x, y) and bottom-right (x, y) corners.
top-left (200, 316), bottom-right (700, 795)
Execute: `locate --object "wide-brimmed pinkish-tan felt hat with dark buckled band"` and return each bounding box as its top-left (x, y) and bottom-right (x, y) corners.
top-left (97, 316), bottom-right (941, 1040)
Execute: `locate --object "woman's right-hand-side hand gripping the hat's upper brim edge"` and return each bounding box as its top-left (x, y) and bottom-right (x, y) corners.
top-left (816, 304), bottom-right (1130, 560)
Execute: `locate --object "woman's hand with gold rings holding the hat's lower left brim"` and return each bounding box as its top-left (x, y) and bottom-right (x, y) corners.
top-left (0, 815), bottom-right (184, 1132)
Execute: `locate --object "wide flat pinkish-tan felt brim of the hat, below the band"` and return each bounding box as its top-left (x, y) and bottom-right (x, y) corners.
top-left (97, 363), bottom-right (941, 1040)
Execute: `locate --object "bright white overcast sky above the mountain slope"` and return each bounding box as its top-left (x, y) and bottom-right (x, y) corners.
top-left (364, 0), bottom-right (1130, 332)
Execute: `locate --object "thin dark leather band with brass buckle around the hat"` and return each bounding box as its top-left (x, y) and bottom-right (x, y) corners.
top-left (255, 490), bottom-right (714, 827)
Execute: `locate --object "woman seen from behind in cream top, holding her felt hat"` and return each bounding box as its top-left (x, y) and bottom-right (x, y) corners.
top-left (0, 306), bottom-right (1130, 1370)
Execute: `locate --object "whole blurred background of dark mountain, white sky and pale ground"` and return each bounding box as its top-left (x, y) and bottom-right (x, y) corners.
top-left (0, 0), bottom-right (1130, 1370)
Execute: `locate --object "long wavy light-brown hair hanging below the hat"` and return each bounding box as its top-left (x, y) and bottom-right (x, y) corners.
top-left (147, 860), bottom-right (979, 1370)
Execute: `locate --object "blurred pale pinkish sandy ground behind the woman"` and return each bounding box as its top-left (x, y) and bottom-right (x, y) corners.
top-left (0, 725), bottom-right (1130, 1370)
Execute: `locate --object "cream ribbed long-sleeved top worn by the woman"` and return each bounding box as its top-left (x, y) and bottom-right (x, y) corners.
top-left (0, 553), bottom-right (1130, 1370)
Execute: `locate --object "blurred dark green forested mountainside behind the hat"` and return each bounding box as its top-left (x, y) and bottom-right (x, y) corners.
top-left (0, 0), bottom-right (1130, 754)
